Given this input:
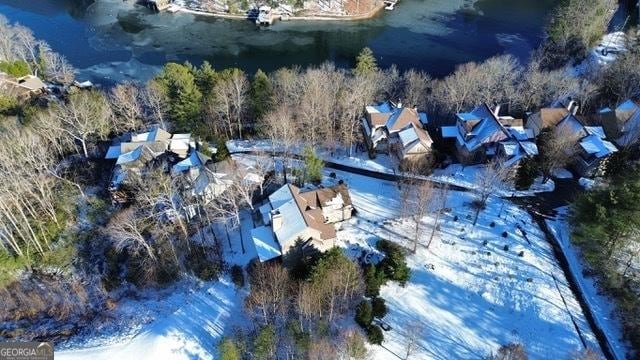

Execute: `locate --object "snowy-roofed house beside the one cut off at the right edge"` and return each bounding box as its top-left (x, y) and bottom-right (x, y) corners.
top-left (555, 113), bottom-right (618, 177)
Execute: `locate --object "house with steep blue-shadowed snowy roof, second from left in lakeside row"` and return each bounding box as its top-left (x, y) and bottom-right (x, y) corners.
top-left (442, 104), bottom-right (538, 165)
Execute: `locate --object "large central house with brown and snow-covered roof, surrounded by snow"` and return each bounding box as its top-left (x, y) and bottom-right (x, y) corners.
top-left (251, 184), bottom-right (353, 261)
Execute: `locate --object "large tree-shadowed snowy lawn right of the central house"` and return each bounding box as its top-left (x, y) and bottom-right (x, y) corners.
top-left (330, 172), bottom-right (599, 359)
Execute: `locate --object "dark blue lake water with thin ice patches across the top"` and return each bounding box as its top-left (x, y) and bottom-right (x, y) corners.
top-left (0, 0), bottom-right (555, 82)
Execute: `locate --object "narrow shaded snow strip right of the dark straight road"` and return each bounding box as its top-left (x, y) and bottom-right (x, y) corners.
top-left (547, 207), bottom-right (629, 359)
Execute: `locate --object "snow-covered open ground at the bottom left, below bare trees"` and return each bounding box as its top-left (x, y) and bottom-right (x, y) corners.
top-left (56, 279), bottom-right (243, 360)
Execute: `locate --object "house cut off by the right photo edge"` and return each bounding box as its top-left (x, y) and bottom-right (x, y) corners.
top-left (598, 99), bottom-right (640, 147)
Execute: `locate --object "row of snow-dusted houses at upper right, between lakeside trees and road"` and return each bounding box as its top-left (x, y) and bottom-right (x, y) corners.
top-left (362, 99), bottom-right (640, 177)
